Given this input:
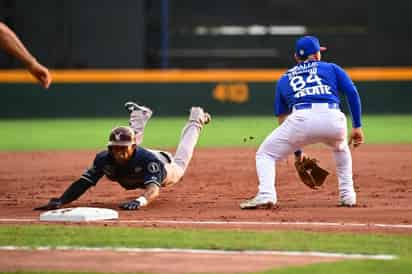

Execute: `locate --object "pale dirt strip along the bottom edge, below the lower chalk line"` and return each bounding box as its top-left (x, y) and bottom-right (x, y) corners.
top-left (0, 250), bottom-right (343, 273)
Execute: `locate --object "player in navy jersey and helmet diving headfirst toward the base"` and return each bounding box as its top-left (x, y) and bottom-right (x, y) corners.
top-left (35, 102), bottom-right (211, 210)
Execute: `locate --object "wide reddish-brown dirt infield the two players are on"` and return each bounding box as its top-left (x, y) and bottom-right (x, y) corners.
top-left (0, 145), bottom-right (412, 272)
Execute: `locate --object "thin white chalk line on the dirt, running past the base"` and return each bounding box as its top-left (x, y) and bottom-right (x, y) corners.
top-left (0, 218), bottom-right (412, 229)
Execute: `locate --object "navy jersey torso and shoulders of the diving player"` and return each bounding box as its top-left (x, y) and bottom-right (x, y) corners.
top-left (81, 147), bottom-right (166, 189)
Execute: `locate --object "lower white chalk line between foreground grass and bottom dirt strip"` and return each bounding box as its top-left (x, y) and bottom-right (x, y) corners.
top-left (0, 246), bottom-right (398, 260)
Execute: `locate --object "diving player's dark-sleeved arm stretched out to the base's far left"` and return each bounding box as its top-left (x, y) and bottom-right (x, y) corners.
top-left (34, 178), bottom-right (92, 210)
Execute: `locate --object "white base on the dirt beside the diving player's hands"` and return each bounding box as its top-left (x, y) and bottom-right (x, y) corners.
top-left (40, 207), bottom-right (119, 222)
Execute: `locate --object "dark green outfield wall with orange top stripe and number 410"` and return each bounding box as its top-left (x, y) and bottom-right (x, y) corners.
top-left (0, 68), bottom-right (412, 118)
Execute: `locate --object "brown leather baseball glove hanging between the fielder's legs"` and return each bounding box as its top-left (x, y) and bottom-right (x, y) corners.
top-left (295, 156), bottom-right (329, 189)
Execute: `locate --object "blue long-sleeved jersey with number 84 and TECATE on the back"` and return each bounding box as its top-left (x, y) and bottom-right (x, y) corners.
top-left (275, 60), bottom-right (361, 127)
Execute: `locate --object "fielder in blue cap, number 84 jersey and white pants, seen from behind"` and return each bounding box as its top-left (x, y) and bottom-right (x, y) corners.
top-left (240, 36), bottom-right (364, 209)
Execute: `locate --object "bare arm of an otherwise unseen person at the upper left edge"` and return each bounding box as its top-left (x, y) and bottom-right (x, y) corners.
top-left (0, 22), bottom-right (52, 88)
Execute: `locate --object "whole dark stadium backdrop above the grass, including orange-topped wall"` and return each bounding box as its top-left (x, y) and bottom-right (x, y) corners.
top-left (0, 0), bottom-right (412, 118)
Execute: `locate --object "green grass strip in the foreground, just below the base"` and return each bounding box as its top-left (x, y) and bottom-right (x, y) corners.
top-left (0, 225), bottom-right (412, 274)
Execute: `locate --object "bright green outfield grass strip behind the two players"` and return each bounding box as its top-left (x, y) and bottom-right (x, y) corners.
top-left (0, 115), bottom-right (412, 151)
